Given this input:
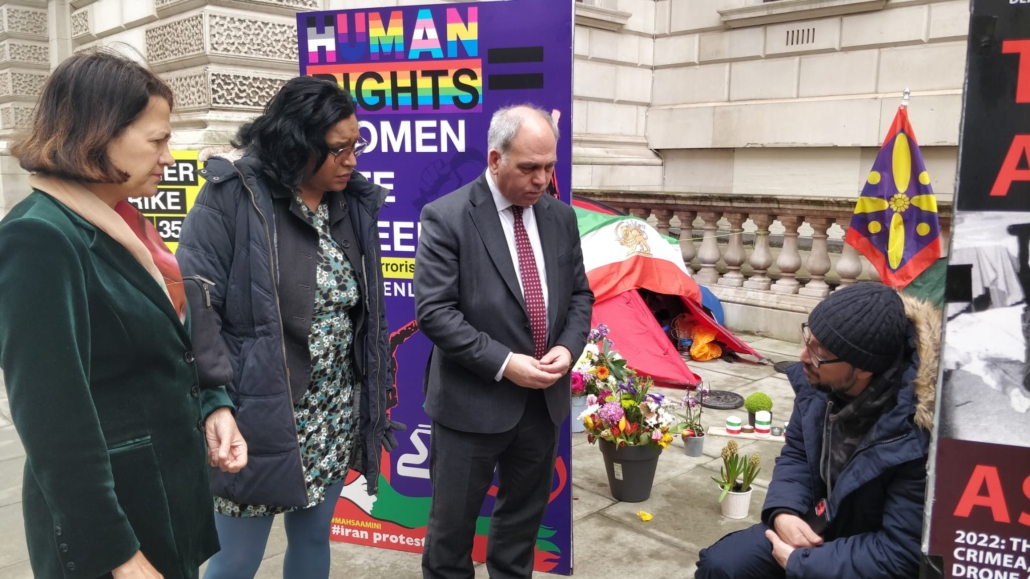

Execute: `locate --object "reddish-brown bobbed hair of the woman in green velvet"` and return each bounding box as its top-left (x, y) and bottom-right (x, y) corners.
top-left (11, 50), bottom-right (173, 183)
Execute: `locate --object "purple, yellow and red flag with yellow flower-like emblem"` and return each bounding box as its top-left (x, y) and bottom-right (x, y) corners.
top-left (845, 107), bottom-right (940, 290)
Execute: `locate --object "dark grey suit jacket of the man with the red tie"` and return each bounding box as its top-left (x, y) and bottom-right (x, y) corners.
top-left (415, 174), bottom-right (593, 434)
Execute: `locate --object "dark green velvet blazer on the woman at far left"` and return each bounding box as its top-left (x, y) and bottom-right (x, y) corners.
top-left (0, 191), bottom-right (232, 579)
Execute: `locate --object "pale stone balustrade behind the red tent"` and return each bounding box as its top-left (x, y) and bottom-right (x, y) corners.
top-left (576, 191), bottom-right (952, 341)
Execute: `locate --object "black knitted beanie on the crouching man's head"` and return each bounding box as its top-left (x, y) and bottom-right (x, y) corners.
top-left (809, 283), bottom-right (908, 374)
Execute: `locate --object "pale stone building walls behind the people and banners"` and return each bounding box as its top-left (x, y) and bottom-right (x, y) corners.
top-left (0, 0), bottom-right (969, 218)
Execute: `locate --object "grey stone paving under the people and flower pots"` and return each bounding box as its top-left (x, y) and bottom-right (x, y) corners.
top-left (0, 336), bottom-right (798, 579)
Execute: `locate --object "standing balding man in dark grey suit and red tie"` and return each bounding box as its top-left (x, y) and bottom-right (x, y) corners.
top-left (415, 106), bottom-right (593, 579)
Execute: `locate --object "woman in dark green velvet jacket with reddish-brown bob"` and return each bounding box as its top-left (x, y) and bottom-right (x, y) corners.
top-left (0, 53), bottom-right (246, 579)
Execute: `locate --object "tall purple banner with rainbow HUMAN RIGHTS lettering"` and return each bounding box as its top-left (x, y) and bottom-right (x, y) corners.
top-left (297, 0), bottom-right (574, 575)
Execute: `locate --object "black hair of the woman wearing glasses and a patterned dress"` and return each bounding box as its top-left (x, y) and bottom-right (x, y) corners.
top-left (233, 76), bottom-right (357, 191)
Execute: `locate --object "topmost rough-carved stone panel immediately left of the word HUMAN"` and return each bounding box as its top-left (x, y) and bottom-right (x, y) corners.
top-left (208, 14), bottom-right (298, 62)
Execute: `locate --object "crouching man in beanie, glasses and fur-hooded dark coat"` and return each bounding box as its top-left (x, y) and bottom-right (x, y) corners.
top-left (694, 283), bottom-right (940, 579)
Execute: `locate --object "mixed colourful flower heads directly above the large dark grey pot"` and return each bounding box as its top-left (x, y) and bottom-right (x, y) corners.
top-left (579, 369), bottom-right (679, 449)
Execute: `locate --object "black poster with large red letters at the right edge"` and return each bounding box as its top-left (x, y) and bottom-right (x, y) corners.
top-left (924, 0), bottom-right (1030, 579)
